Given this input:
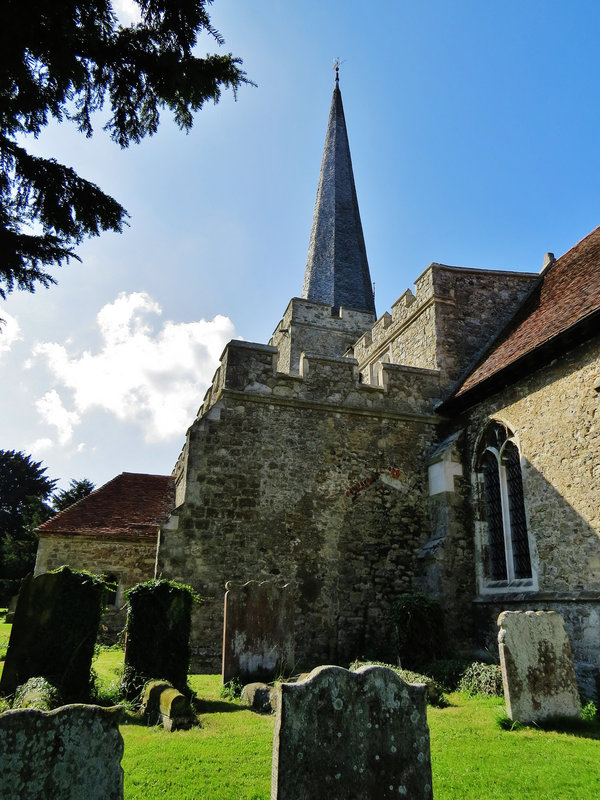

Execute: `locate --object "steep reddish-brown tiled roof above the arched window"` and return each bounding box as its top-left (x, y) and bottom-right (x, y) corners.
top-left (450, 227), bottom-right (600, 399)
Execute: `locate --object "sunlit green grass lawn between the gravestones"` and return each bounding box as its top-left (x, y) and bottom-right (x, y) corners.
top-left (0, 644), bottom-right (600, 800)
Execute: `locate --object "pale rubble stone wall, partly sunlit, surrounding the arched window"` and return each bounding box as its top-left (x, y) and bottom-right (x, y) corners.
top-left (454, 332), bottom-right (600, 686)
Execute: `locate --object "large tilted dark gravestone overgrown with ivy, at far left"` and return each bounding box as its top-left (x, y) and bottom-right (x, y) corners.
top-left (0, 567), bottom-right (104, 702)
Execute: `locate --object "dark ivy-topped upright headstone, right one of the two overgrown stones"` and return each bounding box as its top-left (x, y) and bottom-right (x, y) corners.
top-left (122, 580), bottom-right (194, 699)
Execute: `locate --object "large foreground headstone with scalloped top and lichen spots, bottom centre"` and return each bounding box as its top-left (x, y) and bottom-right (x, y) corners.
top-left (271, 666), bottom-right (433, 800)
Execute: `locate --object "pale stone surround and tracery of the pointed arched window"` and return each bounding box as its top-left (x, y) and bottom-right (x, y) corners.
top-left (473, 420), bottom-right (539, 595)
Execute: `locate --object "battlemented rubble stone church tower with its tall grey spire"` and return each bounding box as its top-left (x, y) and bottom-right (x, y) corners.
top-left (157, 75), bottom-right (532, 668)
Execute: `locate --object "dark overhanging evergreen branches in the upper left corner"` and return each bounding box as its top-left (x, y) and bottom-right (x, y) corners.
top-left (0, 0), bottom-right (251, 297)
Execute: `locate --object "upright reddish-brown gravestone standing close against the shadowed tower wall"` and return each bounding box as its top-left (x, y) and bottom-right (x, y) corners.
top-left (222, 581), bottom-right (294, 684)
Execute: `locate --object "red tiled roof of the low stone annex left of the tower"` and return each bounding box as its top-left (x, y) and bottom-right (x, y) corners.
top-left (37, 472), bottom-right (175, 537)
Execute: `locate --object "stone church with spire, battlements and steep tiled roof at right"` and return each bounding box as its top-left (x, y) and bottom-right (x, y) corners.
top-left (37, 76), bottom-right (600, 692)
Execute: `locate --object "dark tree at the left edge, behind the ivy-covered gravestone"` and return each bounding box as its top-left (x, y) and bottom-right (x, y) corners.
top-left (0, 450), bottom-right (56, 588)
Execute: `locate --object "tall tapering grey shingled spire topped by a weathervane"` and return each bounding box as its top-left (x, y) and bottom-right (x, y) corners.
top-left (302, 66), bottom-right (375, 314)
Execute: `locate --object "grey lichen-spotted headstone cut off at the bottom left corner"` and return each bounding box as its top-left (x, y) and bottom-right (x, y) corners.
top-left (0, 705), bottom-right (123, 800)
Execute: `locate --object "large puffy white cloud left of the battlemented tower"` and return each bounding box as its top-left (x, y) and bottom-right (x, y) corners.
top-left (34, 292), bottom-right (235, 444)
